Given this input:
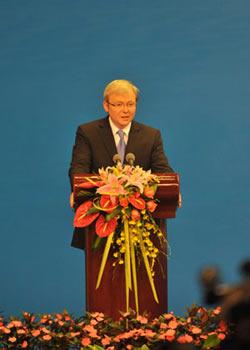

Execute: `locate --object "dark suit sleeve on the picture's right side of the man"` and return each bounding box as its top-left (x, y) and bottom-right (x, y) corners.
top-left (151, 130), bottom-right (174, 173)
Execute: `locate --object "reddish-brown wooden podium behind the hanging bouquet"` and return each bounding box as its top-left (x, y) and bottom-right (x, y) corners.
top-left (74, 173), bottom-right (179, 320)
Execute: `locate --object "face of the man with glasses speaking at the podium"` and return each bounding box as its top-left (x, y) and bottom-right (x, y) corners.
top-left (103, 91), bottom-right (136, 129)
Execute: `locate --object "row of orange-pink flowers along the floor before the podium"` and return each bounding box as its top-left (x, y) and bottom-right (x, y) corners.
top-left (0, 305), bottom-right (229, 350)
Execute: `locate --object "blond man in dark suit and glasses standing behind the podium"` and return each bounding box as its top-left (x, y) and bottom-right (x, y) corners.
top-left (69, 80), bottom-right (173, 249)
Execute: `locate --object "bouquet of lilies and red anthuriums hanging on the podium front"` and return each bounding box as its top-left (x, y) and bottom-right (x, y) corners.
top-left (74, 164), bottom-right (166, 313)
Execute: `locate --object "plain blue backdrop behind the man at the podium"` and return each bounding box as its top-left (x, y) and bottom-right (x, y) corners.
top-left (0, 0), bottom-right (250, 315)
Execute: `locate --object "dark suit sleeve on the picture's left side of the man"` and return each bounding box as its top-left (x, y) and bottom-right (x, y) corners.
top-left (69, 127), bottom-right (92, 188)
